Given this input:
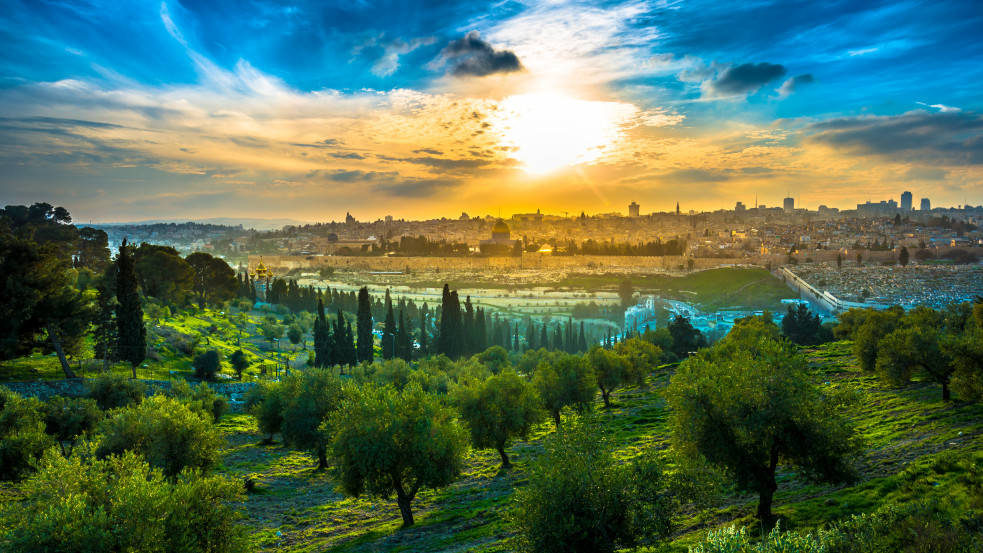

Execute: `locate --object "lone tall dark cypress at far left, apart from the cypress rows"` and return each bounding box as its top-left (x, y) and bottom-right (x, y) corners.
top-left (116, 238), bottom-right (147, 378)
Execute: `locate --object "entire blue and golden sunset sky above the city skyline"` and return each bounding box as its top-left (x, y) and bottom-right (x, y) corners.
top-left (0, 0), bottom-right (983, 222)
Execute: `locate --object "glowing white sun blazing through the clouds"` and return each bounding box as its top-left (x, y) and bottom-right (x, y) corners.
top-left (490, 94), bottom-right (638, 174)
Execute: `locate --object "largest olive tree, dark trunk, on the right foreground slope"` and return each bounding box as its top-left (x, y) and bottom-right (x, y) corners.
top-left (667, 332), bottom-right (859, 520)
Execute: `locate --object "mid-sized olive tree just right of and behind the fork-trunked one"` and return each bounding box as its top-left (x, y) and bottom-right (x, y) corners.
top-left (452, 369), bottom-right (543, 467)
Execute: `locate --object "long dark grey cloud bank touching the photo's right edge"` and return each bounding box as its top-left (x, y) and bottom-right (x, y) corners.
top-left (805, 111), bottom-right (983, 165)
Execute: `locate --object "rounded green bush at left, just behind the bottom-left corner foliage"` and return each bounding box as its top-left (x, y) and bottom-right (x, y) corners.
top-left (96, 395), bottom-right (222, 478)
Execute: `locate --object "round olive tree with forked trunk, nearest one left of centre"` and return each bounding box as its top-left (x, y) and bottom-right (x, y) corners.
top-left (322, 385), bottom-right (467, 526)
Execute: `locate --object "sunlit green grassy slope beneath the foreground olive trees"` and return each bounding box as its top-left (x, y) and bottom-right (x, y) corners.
top-left (213, 342), bottom-right (983, 552)
